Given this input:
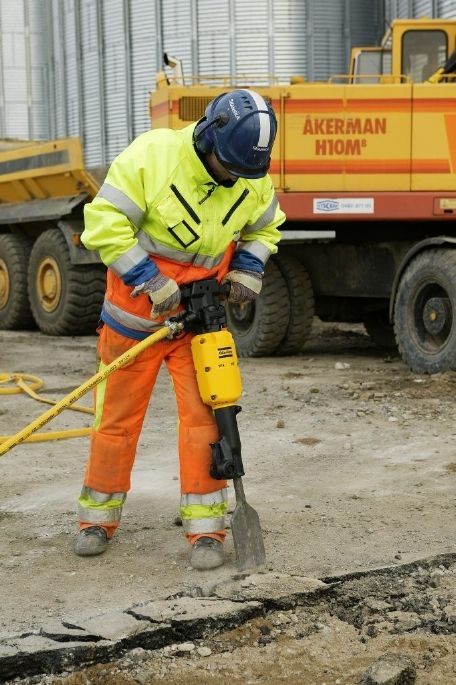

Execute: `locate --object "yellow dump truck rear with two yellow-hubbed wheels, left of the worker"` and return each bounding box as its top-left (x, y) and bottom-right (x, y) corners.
top-left (0, 138), bottom-right (106, 335)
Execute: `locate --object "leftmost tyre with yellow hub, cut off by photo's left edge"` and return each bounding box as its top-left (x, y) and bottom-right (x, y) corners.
top-left (0, 233), bottom-right (35, 331)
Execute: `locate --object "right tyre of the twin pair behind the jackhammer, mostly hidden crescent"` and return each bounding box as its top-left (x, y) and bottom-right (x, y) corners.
top-left (273, 254), bottom-right (315, 356)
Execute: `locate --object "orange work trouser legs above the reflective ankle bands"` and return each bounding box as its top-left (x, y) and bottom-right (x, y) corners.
top-left (81, 325), bottom-right (227, 537)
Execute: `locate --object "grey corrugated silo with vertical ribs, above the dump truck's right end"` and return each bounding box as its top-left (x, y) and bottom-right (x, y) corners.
top-left (51, 0), bottom-right (157, 167)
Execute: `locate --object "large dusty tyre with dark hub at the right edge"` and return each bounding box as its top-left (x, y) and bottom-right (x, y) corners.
top-left (394, 248), bottom-right (456, 374)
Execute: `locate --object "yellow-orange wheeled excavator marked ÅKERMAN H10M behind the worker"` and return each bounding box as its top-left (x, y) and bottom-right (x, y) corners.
top-left (150, 19), bottom-right (456, 373)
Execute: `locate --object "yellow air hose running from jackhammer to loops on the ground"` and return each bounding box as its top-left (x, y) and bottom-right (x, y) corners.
top-left (0, 323), bottom-right (178, 457)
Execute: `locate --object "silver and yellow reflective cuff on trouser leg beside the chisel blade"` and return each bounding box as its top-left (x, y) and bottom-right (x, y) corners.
top-left (180, 488), bottom-right (228, 534)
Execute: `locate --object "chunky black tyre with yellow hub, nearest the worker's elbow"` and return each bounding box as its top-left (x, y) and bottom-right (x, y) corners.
top-left (28, 229), bottom-right (106, 335)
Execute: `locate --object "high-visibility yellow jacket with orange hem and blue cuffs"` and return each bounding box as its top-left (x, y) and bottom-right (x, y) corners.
top-left (81, 124), bottom-right (285, 339)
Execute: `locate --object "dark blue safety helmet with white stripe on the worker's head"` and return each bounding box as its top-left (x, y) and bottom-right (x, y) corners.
top-left (193, 89), bottom-right (277, 178)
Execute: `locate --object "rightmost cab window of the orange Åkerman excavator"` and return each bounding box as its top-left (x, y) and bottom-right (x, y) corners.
top-left (402, 30), bottom-right (448, 83)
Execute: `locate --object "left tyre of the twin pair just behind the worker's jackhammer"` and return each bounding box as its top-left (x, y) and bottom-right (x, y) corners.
top-left (226, 260), bottom-right (290, 357)
